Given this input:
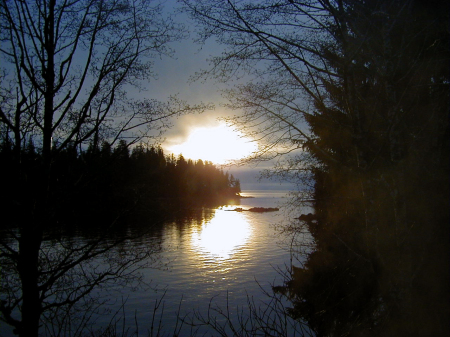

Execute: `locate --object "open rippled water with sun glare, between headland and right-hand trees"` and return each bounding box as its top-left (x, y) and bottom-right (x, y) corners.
top-left (0, 190), bottom-right (311, 336)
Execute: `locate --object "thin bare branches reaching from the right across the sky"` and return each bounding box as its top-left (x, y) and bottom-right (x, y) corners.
top-left (181, 1), bottom-right (328, 160)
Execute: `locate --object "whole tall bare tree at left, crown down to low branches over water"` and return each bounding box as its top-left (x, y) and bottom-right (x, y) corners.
top-left (0, 0), bottom-right (207, 336)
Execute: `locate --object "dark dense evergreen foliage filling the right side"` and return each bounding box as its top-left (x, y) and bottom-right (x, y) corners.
top-left (289, 1), bottom-right (449, 336)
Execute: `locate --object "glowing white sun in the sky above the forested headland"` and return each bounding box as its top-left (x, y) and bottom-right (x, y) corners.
top-left (168, 124), bottom-right (257, 164)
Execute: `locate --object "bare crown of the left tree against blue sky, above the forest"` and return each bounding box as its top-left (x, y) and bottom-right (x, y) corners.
top-left (0, 1), bottom-right (207, 157)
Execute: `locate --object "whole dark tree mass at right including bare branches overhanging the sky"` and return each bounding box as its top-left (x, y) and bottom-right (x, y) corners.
top-left (183, 0), bottom-right (450, 336)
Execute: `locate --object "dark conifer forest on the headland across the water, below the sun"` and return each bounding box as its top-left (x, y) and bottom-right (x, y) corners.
top-left (0, 141), bottom-right (241, 228)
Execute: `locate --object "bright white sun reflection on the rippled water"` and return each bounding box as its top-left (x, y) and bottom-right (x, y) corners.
top-left (192, 210), bottom-right (252, 262)
